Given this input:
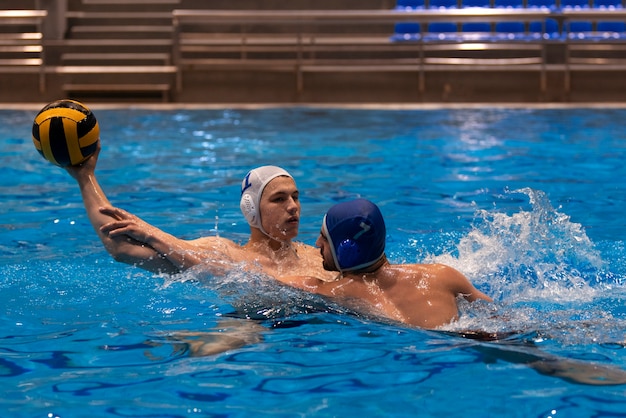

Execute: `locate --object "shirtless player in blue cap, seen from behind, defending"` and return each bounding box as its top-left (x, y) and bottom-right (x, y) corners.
top-left (282, 199), bottom-right (491, 329)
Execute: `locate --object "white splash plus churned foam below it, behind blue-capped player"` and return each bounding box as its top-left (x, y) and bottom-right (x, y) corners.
top-left (425, 188), bottom-right (623, 342)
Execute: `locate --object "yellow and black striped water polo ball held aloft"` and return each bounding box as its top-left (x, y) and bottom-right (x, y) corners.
top-left (33, 99), bottom-right (100, 167)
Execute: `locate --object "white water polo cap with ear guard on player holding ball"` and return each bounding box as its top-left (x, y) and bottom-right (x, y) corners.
top-left (239, 165), bottom-right (295, 235)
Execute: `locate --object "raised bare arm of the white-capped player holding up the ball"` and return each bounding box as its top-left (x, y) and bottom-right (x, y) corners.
top-left (65, 144), bottom-right (178, 273)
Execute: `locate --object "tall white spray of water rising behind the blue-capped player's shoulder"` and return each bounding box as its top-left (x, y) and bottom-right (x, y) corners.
top-left (429, 188), bottom-right (606, 303)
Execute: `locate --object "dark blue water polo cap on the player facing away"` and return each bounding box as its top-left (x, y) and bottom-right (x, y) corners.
top-left (322, 199), bottom-right (387, 272)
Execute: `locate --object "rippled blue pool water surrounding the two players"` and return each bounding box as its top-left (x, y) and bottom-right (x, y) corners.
top-left (0, 107), bottom-right (626, 418)
